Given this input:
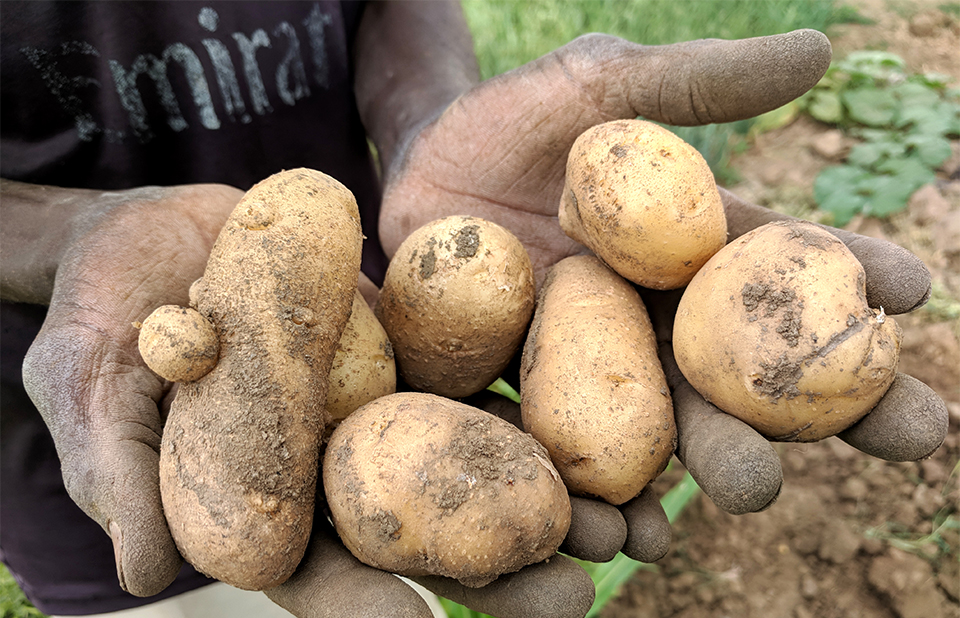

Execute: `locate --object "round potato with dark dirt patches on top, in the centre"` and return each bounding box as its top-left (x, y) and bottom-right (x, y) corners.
top-left (376, 216), bottom-right (536, 398)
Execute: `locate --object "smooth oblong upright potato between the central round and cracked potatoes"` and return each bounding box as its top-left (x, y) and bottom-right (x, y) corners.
top-left (520, 256), bottom-right (677, 504)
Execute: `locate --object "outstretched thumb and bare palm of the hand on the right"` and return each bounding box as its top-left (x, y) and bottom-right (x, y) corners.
top-left (380, 30), bottom-right (831, 275)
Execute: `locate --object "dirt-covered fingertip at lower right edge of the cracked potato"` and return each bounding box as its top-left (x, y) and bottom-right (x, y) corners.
top-left (838, 373), bottom-right (950, 461)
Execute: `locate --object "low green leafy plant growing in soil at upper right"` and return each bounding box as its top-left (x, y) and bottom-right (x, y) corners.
top-left (802, 51), bottom-right (960, 226)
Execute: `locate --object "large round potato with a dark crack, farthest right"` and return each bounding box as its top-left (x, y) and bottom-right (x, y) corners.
top-left (673, 221), bottom-right (901, 442)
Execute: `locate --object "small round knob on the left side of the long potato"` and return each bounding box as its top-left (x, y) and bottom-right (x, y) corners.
top-left (138, 305), bottom-right (220, 382)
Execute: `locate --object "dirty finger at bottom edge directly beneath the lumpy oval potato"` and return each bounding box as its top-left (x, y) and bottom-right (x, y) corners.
top-left (412, 554), bottom-right (595, 618)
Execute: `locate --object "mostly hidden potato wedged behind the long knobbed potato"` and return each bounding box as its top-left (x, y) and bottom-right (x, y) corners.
top-left (326, 290), bottom-right (397, 430)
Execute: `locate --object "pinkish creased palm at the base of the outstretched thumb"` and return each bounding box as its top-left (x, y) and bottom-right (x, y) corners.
top-left (381, 51), bottom-right (605, 271)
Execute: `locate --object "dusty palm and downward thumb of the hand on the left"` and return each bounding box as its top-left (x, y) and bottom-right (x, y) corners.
top-left (17, 185), bottom-right (242, 596)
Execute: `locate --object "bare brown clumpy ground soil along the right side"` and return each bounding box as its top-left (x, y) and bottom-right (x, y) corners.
top-left (601, 0), bottom-right (960, 618)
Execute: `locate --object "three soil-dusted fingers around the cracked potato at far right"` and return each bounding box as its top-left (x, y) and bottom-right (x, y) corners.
top-left (643, 191), bottom-right (949, 514)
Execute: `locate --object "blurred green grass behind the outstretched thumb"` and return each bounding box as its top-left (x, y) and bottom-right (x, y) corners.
top-left (463, 0), bottom-right (862, 184)
